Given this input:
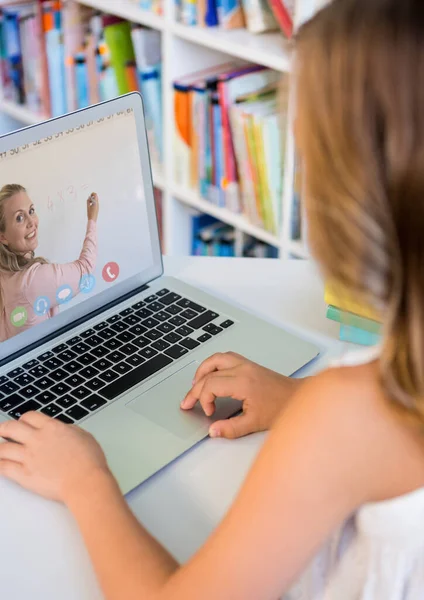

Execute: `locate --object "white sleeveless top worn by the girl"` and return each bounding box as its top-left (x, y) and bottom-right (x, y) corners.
top-left (282, 348), bottom-right (424, 600)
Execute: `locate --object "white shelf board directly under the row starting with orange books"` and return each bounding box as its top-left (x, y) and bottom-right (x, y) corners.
top-left (171, 185), bottom-right (281, 248)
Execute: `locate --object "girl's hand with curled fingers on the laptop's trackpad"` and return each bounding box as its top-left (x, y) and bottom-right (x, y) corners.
top-left (181, 352), bottom-right (302, 438)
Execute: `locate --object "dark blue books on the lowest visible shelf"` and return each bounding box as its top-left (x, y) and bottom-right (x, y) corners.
top-left (191, 214), bottom-right (278, 258)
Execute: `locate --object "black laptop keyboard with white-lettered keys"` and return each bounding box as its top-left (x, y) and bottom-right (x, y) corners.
top-left (0, 289), bottom-right (234, 423)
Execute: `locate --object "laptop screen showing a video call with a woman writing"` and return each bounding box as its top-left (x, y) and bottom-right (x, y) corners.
top-left (0, 96), bottom-right (161, 359)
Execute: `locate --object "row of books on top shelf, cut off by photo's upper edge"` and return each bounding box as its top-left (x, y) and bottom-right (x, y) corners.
top-left (175, 0), bottom-right (295, 38)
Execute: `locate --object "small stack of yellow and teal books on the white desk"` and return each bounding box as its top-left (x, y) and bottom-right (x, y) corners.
top-left (325, 286), bottom-right (382, 346)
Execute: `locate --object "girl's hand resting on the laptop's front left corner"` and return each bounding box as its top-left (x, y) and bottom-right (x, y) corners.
top-left (0, 412), bottom-right (112, 503)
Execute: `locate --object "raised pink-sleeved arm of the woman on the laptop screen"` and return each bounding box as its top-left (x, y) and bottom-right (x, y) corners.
top-left (22, 220), bottom-right (97, 307)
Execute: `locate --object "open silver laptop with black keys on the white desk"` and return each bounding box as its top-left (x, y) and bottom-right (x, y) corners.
top-left (0, 93), bottom-right (319, 493)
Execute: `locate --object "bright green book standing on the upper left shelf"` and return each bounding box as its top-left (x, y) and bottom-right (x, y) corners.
top-left (104, 21), bottom-right (135, 94)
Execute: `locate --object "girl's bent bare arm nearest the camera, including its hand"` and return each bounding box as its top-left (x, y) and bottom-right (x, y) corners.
top-left (0, 367), bottom-right (388, 600)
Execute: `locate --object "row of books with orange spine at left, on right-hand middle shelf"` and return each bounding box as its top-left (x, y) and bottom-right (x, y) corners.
top-left (174, 63), bottom-right (288, 235)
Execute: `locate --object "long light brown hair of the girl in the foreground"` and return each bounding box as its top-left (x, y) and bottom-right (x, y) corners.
top-left (296, 0), bottom-right (424, 425)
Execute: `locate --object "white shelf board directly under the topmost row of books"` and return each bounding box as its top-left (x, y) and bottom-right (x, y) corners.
top-left (171, 23), bottom-right (291, 73)
